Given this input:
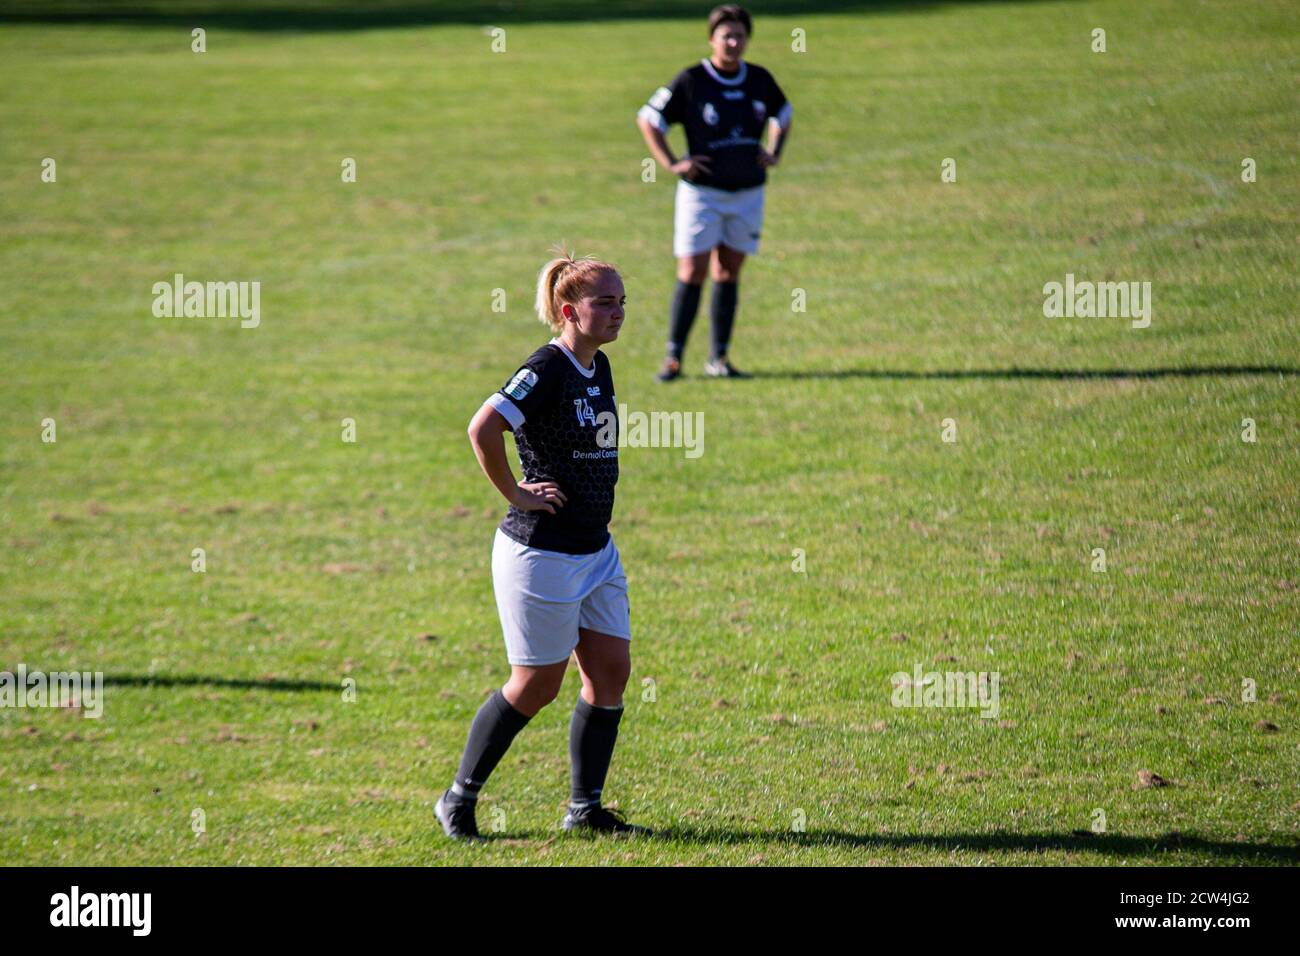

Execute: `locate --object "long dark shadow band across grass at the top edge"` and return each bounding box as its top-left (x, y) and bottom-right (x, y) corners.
top-left (0, 0), bottom-right (1055, 31)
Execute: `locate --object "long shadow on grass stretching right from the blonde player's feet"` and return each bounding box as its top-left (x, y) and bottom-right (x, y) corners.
top-left (485, 827), bottom-right (1300, 864)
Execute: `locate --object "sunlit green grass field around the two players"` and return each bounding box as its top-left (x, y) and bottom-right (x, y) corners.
top-left (0, 0), bottom-right (1300, 865)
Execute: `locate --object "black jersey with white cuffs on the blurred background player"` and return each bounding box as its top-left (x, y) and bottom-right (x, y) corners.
top-left (637, 60), bottom-right (790, 191)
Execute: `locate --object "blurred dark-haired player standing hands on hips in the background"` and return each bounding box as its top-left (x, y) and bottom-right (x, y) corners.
top-left (637, 4), bottom-right (790, 381)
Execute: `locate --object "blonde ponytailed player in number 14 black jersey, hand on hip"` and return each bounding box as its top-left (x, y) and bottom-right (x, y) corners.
top-left (434, 256), bottom-right (650, 839)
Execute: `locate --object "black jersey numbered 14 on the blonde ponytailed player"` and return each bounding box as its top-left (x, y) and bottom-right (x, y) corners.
top-left (488, 338), bottom-right (619, 554)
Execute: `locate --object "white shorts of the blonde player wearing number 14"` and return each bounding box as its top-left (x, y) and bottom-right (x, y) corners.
top-left (491, 528), bottom-right (632, 667)
